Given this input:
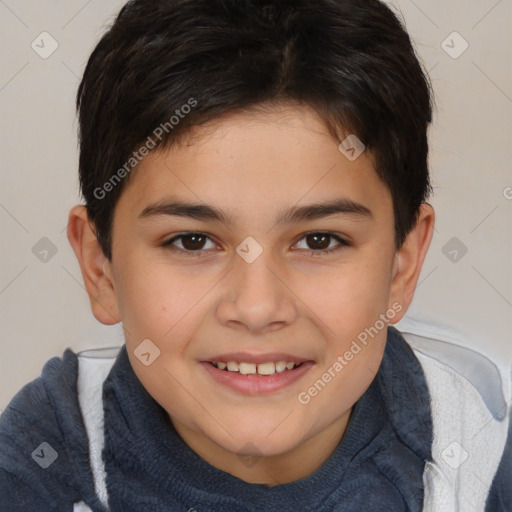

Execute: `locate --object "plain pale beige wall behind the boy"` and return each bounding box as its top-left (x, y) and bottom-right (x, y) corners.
top-left (0, 0), bottom-right (512, 409)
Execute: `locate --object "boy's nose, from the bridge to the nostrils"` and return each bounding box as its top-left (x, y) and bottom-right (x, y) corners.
top-left (217, 250), bottom-right (298, 334)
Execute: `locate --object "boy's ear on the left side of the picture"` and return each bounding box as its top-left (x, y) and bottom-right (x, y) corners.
top-left (67, 205), bottom-right (121, 325)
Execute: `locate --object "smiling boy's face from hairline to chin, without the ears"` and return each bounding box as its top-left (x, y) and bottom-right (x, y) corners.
top-left (107, 104), bottom-right (412, 472)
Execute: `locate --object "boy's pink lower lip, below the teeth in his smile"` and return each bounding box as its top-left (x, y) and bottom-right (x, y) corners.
top-left (200, 361), bottom-right (313, 395)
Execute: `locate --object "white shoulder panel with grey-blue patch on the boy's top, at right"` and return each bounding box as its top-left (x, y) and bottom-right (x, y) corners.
top-left (402, 329), bottom-right (510, 511)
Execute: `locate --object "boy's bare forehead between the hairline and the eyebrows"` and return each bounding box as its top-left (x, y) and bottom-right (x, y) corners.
top-left (120, 107), bottom-right (391, 222)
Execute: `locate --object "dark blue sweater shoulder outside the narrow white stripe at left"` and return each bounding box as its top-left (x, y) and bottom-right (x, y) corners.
top-left (0, 349), bottom-right (97, 511)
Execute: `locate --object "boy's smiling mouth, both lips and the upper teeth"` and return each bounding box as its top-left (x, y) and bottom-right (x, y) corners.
top-left (200, 354), bottom-right (315, 396)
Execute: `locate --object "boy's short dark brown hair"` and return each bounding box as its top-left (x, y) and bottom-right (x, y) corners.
top-left (77, 0), bottom-right (432, 258)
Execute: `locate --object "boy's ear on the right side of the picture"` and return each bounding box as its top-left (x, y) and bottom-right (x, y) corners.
top-left (388, 203), bottom-right (435, 324)
